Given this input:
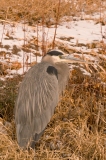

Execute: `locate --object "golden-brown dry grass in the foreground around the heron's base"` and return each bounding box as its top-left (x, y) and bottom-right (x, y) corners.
top-left (0, 68), bottom-right (106, 160)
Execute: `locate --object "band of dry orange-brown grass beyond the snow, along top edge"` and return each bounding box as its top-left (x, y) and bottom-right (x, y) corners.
top-left (0, 0), bottom-right (106, 26)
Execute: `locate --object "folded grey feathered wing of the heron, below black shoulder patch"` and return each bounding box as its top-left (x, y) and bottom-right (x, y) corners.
top-left (15, 63), bottom-right (59, 146)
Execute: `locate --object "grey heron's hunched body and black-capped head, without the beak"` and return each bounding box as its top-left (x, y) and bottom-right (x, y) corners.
top-left (15, 51), bottom-right (85, 148)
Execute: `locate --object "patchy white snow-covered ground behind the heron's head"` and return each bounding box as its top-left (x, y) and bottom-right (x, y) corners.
top-left (0, 14), bottom-right (106, 79)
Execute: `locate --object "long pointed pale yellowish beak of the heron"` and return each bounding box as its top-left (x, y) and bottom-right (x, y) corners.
top-left (60, 54), bottom-right (93, 64)
